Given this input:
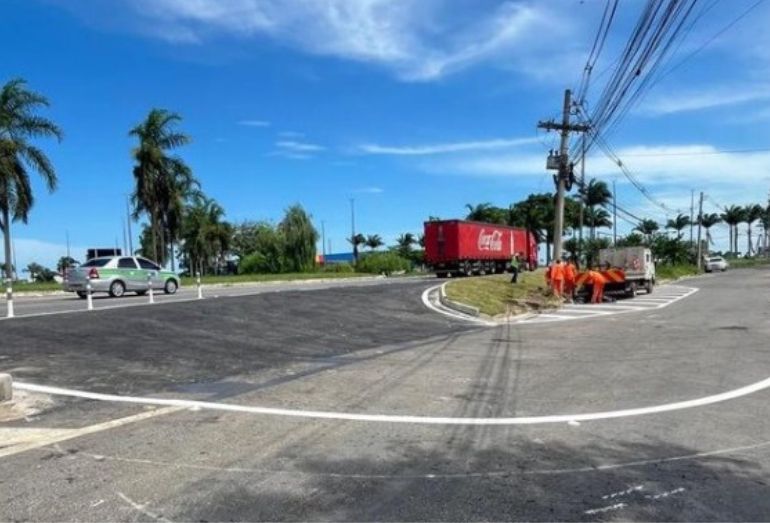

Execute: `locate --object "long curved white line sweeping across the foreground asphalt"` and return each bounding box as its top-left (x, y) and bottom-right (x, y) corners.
top-left (13, 378), bottom-right (770, 425)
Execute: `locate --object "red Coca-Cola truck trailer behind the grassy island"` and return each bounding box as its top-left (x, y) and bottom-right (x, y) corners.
top-left (425, 220), bottom-right (537, 278)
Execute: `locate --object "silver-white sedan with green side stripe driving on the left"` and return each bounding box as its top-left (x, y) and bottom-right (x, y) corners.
top-left (62, 256), bottom-right (180, 298)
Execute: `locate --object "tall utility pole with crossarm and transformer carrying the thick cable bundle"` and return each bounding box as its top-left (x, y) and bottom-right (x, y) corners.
top-left (537, 89), bottom-right (589, 260)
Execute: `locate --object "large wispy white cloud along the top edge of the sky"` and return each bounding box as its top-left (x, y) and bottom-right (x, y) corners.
top-left (112, 0), bottom-right (576, 81)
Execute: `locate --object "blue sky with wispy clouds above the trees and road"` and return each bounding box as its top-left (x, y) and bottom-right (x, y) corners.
top-left (0, 0), bottom-right (770, 266)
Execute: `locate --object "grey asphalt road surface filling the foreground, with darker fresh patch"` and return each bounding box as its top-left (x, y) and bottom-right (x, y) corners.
top-left (0, 270), bottom-right (770, 521)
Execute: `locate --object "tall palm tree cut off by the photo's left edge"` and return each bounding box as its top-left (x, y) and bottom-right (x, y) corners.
top-left (0, 78), bottom-right (62, 280)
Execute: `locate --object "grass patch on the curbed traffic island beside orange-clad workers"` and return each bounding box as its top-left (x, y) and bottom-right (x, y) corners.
top-left (446, 270), bottom-right (561, 316)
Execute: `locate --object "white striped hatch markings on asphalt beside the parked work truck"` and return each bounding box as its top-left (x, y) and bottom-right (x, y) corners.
top-left (511, 285), bottom-right (698, 324)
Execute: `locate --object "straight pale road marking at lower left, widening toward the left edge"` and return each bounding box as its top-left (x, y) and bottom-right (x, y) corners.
top-left (0, 406), bottom-right (182, 458)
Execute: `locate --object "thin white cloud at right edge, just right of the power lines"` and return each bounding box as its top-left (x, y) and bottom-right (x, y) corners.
top-left (639, 84), bottom-right (770, 116)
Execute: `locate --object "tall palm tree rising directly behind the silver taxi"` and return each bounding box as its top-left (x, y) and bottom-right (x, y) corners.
top-left (128, 109), bottom-right (196, 264)
